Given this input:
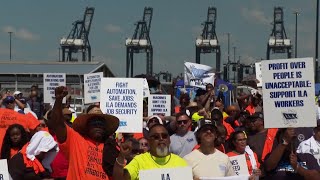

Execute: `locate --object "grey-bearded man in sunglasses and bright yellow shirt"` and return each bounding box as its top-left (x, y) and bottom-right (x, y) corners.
top-left (113, 124), bottom-right (187, 180)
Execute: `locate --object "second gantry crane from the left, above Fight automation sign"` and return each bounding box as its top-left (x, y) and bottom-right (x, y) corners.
top-left (126, 7), bottom-right (153, 77)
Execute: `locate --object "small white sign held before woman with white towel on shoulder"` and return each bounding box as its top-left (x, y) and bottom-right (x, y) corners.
top-left (229, 154), bottom-right (249, 176)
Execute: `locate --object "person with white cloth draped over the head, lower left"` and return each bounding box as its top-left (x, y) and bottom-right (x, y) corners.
top-left (8, 131), bottom-right (59, 180)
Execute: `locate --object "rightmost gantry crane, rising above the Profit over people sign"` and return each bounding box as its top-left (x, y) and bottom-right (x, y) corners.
top-left (267, 7), bottom-right (292, 59)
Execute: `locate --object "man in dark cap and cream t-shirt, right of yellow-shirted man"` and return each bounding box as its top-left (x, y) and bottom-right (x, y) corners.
top-left (184, 119), bottom-right (235, 179)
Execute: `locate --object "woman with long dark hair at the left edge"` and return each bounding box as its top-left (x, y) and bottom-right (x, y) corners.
top-left (0, 124), bottom-right (29, 160)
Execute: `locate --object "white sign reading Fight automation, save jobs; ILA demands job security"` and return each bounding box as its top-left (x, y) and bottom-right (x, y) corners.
top-left (100, 78), bottom-right (143, 133)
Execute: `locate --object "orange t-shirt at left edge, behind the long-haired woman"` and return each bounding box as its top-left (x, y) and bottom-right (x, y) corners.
top-left (0, 108), bottom-right (40, 149)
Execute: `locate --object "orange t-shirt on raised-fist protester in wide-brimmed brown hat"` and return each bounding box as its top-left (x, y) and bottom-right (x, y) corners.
top-left (59, 126), bottom-right (108, 180)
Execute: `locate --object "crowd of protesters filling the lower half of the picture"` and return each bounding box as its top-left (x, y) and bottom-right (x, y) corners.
top-left (0, 84), bottom-right (320, 180)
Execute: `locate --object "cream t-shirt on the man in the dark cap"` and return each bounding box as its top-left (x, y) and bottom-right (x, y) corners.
top-left (184, 149), bottom-right (236, 178)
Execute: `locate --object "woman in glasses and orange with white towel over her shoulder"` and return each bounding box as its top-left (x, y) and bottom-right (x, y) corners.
top-left (227, 131), bottom-right (261, 176)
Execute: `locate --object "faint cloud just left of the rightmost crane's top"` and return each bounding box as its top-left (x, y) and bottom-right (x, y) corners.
top-left (241, 7), bottom-right (272, 25)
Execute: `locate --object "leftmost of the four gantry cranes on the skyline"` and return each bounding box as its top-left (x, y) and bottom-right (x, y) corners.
top-left (60, 7), bottom-right (94, 62)
